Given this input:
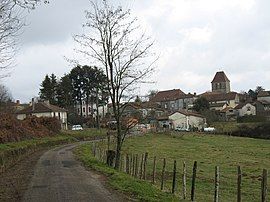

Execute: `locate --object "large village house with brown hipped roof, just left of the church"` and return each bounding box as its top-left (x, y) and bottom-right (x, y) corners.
top-left (150, 89), bottom-right (196, 112)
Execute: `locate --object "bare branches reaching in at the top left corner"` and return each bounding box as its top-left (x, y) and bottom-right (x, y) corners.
top-left (0, 0), bottom-right (48, 78)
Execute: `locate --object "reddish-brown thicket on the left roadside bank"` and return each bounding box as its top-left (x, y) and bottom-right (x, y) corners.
top-left (0, 113), bottom-right (61, 143)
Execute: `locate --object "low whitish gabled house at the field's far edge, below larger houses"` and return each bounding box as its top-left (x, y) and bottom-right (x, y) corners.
top-left (169, 110), bottom-right (206, 130)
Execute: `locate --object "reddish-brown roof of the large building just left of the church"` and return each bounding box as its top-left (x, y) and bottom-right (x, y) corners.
top-left (151, 89), bottom-right (190, 102)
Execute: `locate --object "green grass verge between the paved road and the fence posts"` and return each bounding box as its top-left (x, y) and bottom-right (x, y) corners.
top-left (74, 144), bottom-right (179, 201)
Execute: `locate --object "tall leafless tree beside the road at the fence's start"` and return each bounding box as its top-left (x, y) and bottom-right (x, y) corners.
top-left (74, 0), bottom-right (157, 168)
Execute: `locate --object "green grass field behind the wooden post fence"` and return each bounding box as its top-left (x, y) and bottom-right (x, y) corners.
top-left (96, 133), bottom-right (270, 201)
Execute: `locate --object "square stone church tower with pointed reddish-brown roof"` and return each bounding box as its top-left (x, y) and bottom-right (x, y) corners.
top-left (211, 71), bottom-right (231, 93)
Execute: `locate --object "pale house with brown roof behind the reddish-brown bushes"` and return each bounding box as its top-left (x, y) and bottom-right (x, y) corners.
top-left (16, 101), bottom-right (67, 130)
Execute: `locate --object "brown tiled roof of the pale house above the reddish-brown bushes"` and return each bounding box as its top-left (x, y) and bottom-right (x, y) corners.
top-left (17, 102), bottom-right (67, 114)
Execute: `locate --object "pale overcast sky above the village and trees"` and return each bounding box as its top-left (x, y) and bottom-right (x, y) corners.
top-left (4, 0), bottom-right (270, 102)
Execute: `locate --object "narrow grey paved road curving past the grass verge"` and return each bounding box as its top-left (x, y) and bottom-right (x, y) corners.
top-left (23, 145), bottom-right (125, 202)
